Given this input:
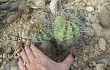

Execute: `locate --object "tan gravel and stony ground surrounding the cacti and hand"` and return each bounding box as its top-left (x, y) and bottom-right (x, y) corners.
top-left (0, 0), bottom-right (110, 70)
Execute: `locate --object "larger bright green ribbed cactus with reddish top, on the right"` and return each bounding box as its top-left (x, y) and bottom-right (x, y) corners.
top-left (53, 16), bottom-right (80, 45)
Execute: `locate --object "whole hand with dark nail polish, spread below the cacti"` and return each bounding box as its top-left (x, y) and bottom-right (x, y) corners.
top-left (18, 44), bottom-right (74, 70)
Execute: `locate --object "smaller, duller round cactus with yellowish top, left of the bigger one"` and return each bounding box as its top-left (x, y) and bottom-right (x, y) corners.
top-left (31, 20), bottom-right (52, 43)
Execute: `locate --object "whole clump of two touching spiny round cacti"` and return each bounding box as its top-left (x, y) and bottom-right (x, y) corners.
top-left (32, 12), bottom-right (80, 46)
